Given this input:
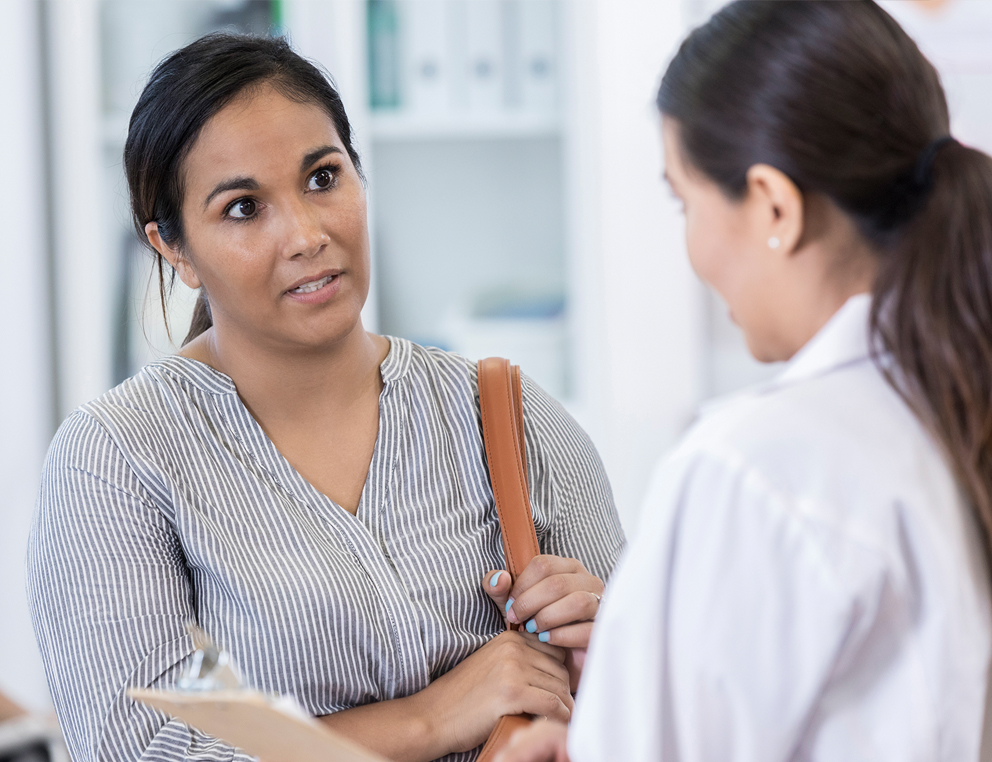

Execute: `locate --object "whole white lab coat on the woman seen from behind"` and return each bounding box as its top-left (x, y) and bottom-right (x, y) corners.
top-left (569, 295), bottom-right (992, 762)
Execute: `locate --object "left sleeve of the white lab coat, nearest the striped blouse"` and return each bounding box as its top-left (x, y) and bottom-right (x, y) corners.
top-left (569, 446), bottom-right (897, 762)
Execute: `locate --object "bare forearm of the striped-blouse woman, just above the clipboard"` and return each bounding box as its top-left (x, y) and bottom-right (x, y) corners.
top-left (320, 691), bottom-right (455, 762)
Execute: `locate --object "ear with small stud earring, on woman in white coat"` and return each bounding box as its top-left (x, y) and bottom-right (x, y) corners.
top-left (747, 164), bottom-right (804, 256)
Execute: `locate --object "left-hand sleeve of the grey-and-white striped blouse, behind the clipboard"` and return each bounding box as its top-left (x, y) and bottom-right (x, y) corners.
top-left (28, 412), bottom-right (251, 762)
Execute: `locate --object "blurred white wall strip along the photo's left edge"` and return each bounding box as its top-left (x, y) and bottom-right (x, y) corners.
top-left (0, 0), bottom-right (53, 709)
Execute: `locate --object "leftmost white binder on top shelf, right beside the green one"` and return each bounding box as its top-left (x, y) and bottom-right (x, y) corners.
top-left (400, 0), bottom-right (451, 117)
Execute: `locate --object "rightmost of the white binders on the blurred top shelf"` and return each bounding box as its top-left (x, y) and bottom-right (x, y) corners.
top-left (516, 0), bottom-right (558, 114)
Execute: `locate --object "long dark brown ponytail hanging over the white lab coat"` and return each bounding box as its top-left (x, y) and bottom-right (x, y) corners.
top-left (871, 142), bottom-right (992, 548)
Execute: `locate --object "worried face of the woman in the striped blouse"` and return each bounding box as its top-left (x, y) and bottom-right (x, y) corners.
top-left (167, 86), bottom-right (369, 351)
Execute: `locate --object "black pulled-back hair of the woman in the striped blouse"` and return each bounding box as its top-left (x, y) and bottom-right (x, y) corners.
top-left (124, 32), bottom-right (361, 344)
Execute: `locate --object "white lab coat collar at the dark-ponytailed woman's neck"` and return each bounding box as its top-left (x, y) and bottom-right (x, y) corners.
top-left (761, 294), bottom-right (871, 392)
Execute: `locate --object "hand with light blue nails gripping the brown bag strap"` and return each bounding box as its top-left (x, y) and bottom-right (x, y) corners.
top-left (482, 556), bottom-right (605, 693)
